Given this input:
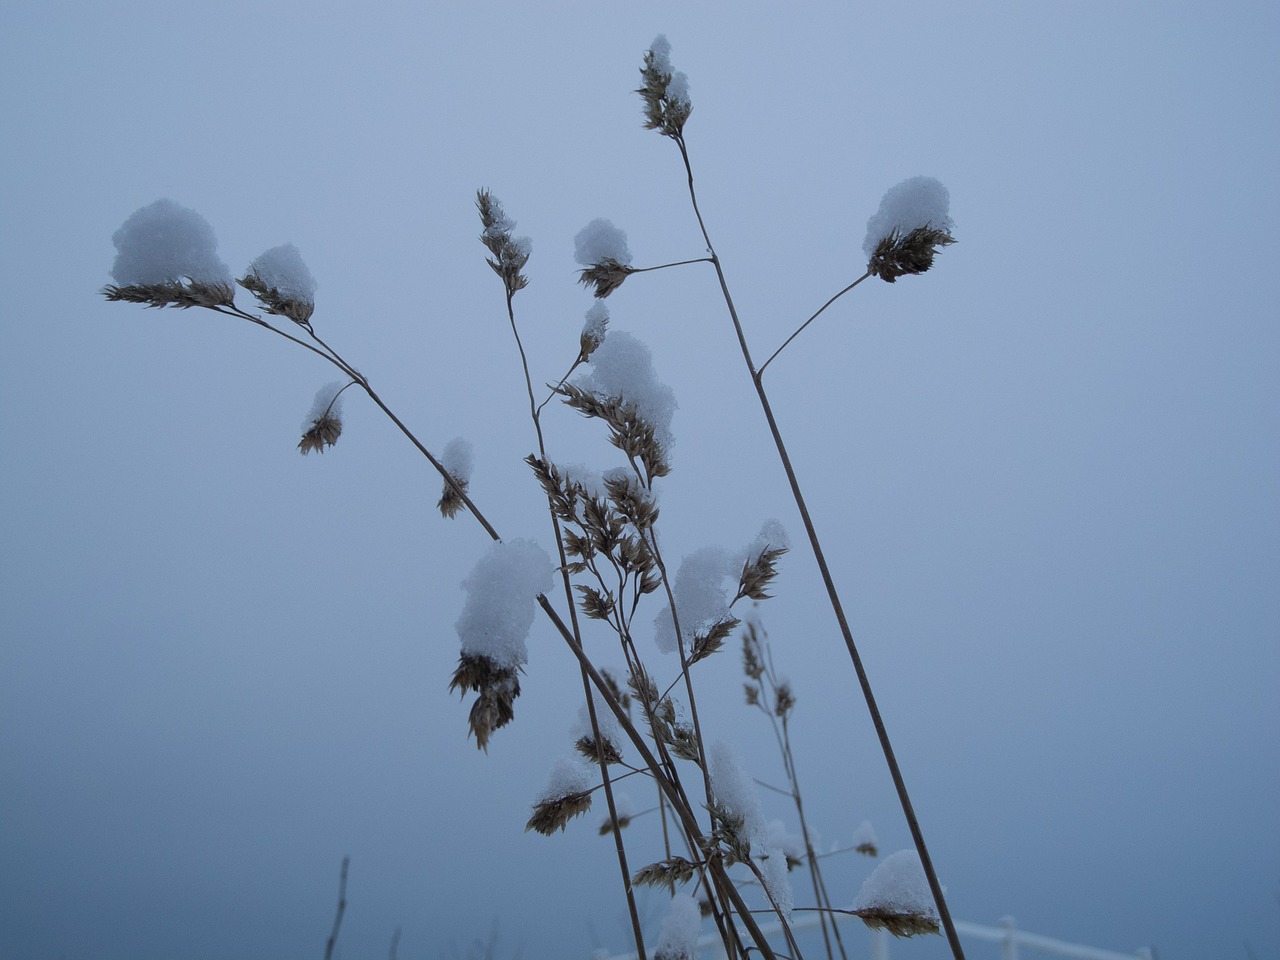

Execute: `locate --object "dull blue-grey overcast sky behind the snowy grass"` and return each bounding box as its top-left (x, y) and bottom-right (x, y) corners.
top-left (0, 0), bottom-right (1280, 960)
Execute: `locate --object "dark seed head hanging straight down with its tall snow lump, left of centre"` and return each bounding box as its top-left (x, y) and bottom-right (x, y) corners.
top-left (449, 540), bottom-right (552, 750)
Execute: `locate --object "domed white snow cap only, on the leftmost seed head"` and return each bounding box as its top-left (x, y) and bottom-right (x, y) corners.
top-left (111, 200), bottom-right (232, 287)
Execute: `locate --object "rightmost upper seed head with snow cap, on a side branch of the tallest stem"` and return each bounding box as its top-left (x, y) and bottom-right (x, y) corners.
top-left (863, 177), bottom-right (955, 283)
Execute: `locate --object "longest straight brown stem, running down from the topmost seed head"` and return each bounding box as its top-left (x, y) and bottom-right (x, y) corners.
top-left (673, 136), bottom-right (964, 960)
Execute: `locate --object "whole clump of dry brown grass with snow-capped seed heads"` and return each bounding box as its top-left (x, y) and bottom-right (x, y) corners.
top-left (102, 36), bottom-right (963, 960)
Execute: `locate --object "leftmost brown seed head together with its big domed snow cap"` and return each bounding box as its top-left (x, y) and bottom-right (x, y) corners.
top-left (102, 200), bottom-right (236, 308)
